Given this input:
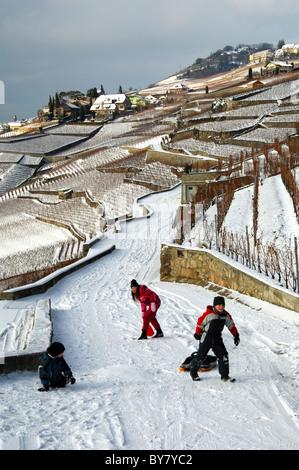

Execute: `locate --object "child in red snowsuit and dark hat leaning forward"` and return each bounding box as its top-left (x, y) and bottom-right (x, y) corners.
top-left (131, 279), bottom-right (164, 339)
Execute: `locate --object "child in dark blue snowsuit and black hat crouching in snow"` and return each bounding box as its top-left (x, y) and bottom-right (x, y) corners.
top-left (38, 343), bottom-right (76, 392)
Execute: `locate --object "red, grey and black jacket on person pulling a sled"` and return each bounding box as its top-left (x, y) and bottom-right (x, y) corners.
top-left (195, 305), bottom-right (238, 342)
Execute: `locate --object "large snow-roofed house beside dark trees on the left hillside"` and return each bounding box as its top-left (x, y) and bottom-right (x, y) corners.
top-left (90, 93), bottom-right (132, 119)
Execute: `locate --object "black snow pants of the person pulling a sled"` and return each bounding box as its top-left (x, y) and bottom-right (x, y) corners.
top-left (190, 334), bottom-right (229, 377)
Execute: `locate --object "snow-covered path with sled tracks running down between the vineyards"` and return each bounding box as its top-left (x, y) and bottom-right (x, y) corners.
top-left (0, 188), bottom-right (299, 450)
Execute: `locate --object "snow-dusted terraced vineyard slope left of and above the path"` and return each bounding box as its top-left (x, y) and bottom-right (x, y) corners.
top-left (0, 70), bottom-right (299, 290)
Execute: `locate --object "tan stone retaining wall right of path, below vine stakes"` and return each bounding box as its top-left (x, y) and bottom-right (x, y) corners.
top-left (160, 244), bottom-right (299, 313)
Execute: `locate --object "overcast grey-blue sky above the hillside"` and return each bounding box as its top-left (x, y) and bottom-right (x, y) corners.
top-left (0, 0), bottom-right (299, 122)
